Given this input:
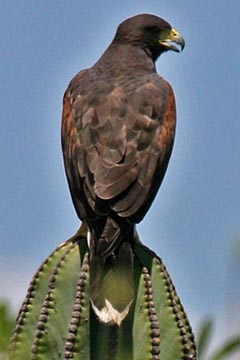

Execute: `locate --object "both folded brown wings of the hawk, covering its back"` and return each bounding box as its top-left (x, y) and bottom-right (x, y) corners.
top-left (62, 70), bottom-right (175, 222)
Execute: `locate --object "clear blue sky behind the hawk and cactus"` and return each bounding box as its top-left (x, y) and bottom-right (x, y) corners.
top-left (0, 0), bottom-right (240, 354)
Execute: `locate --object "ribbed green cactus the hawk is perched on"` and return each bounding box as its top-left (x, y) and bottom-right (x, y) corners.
top-left (9, 233), bottom-right (196, 360)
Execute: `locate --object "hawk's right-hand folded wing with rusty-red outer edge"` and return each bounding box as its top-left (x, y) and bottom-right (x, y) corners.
top-left (110, 74), bottom-right (176, 223)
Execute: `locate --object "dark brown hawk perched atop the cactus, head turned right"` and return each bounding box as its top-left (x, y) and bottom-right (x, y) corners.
top-left (62, 14), bottom-right (184, 325)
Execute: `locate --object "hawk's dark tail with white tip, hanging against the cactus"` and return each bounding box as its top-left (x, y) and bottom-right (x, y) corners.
top-left (90, 218), bottom-right (134, 326)
